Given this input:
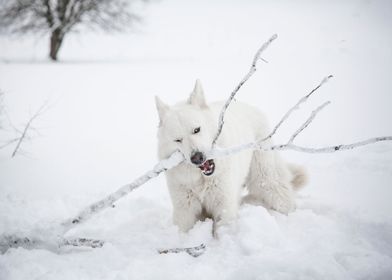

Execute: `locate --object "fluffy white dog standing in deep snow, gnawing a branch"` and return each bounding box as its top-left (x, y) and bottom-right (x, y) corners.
top-left (156, 81), bottom-right (306, 231)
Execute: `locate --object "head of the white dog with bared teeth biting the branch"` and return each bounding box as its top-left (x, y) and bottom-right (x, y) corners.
top-left (155, 80), bottom-right (217, 176)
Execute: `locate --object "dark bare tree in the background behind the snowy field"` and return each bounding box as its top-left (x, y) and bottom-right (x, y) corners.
top-left (0, 0), bottom-right (142, 60)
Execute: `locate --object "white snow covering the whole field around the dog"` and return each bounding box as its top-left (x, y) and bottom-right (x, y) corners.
top-left (0, 0), bottom-right (392, 280)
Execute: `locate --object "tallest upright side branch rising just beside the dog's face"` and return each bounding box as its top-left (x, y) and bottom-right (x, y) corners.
top-left (212, 34), bottom-right (278, 149)
